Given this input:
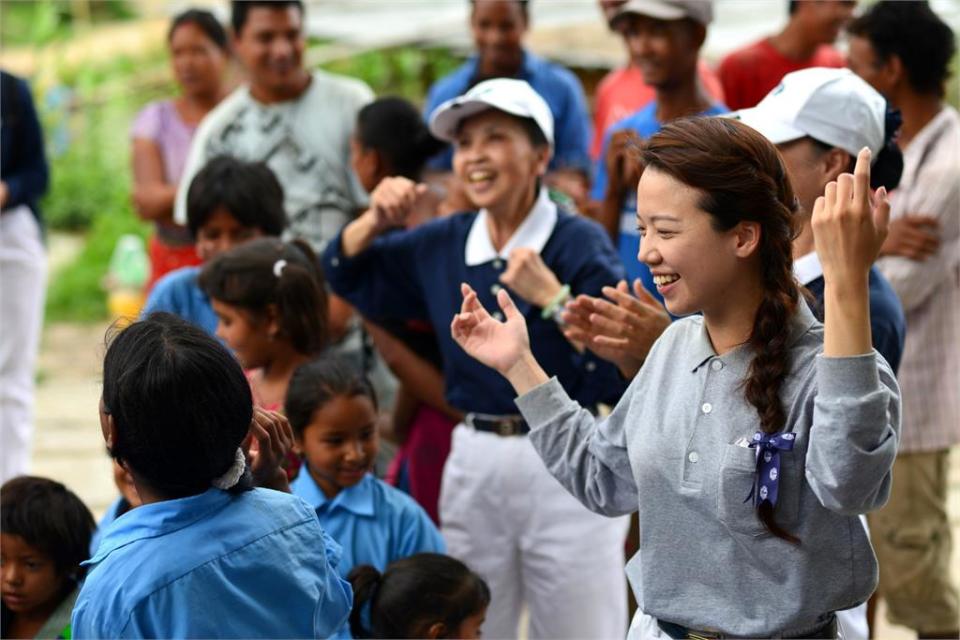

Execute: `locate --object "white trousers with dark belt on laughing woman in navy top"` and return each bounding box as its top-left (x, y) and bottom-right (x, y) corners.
top-left (440, 424), bottom-right (629, 639)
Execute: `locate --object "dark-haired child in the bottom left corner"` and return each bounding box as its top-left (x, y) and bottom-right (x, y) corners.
top-left (0, 476), bottom-right (94, 638)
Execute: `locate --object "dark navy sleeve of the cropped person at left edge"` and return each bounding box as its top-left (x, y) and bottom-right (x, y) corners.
top-left (3, 79), bottom-right (49, 208)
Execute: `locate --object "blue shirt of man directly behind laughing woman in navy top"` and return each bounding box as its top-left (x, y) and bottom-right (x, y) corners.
top-left (424, 51), bottom-right (592, 175)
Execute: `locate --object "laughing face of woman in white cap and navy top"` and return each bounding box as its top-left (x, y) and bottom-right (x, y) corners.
top-left (453, 109), bottom-right (550, 215)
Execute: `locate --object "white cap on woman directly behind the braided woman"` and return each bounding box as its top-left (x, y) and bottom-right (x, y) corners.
top-left (730, 67), bottom-right (887, 161)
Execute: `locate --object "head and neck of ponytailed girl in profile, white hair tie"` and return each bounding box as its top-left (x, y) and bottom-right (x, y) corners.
top-left (198, 238), bottom-right (327, 410)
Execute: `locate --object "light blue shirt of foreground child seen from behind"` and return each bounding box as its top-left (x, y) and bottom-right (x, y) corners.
top-left (72, 489), bottom-right (353, 638)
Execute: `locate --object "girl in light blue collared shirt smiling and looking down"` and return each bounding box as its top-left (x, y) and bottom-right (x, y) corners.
top-left (284, 358), bottom-right (446, 577)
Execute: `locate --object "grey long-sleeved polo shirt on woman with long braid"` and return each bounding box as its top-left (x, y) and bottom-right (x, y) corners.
top-left (517, 303), bottom-right (900, 637)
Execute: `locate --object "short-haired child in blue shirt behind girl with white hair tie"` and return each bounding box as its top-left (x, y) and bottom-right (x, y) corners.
top-left (143, 156), bottom-right (287, 335)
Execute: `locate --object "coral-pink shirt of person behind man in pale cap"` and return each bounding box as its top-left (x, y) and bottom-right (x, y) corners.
top-left (590, 60), bottom-right (724, 160)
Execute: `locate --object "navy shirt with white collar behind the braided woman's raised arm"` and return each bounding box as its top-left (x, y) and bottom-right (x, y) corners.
top-left (793, 253), bottom-right (907, 374)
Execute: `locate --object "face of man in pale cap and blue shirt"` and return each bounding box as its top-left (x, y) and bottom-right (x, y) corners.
top-left (614, 13), bottom-right (704, 89)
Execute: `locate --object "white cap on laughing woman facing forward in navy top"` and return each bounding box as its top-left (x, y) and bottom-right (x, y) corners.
top-left (430, 78), bottom-right (553, 147)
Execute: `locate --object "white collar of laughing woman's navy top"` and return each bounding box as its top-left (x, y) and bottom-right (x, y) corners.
top-left (464, 188), bottom-right (557, 267)
